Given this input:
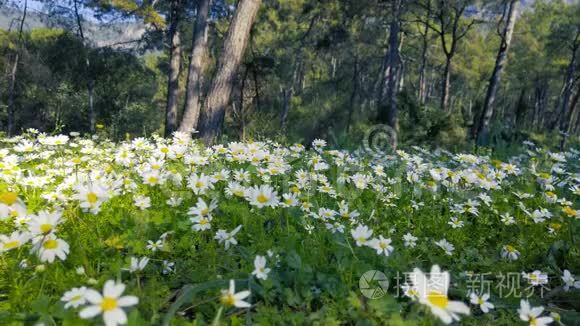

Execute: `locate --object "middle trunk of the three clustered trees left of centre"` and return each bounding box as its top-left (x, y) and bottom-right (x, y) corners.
top-left (179, 0), bottom-right (211, 133)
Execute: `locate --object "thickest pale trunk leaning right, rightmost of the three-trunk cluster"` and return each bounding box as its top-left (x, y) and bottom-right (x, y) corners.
top-left (200, 0), bottom-right (261, 144)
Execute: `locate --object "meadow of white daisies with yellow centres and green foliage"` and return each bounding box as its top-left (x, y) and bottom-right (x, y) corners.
top-left (0, 132), bottom-right (580, 325)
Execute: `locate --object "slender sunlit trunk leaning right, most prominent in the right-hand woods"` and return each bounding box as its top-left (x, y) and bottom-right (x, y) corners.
top-left (477, 0), bottom-right (519, 146)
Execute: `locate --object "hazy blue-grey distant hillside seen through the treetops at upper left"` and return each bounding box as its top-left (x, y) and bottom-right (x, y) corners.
top-left (0, 7), bottom-right (145, 47)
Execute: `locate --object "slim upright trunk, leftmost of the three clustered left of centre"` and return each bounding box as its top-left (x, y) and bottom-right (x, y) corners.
top-left (165, 0), bottom-right (181, 137)
